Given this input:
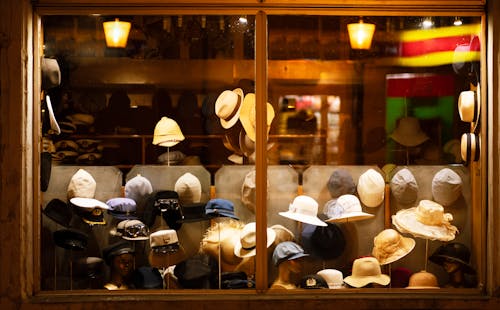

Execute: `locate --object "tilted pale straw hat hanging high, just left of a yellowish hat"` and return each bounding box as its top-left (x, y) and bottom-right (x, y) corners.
top-left (215, 88), bottom-right (243, 129)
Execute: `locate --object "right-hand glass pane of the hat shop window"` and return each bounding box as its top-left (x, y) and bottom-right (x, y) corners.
top-left (267, 15), bottom-right (481, 289)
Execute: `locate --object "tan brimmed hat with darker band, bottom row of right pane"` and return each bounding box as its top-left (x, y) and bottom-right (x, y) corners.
top-left (344, 256), bottom-right (391, 288)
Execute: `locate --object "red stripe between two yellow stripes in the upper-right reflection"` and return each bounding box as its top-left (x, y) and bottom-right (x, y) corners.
top-left (399, 35), bottom-right (480, 57)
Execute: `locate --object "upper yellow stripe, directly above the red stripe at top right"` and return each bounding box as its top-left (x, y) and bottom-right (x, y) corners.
top-left (400, 24), bottom-right (481, 42)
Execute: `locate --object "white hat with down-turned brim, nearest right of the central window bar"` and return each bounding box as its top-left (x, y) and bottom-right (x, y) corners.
top-left (279, 195), bottom-right (327, 226)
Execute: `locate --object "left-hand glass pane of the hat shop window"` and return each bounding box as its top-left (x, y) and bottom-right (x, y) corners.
top-left (41, 15), bottom-right (255, 290)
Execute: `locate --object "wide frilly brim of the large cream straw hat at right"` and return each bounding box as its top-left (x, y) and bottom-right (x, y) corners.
top-left (392, 207), bottom-right (458, 241)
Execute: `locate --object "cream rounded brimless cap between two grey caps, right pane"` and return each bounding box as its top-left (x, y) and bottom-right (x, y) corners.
top-left (357, 168), bottom-right (385, 208)
